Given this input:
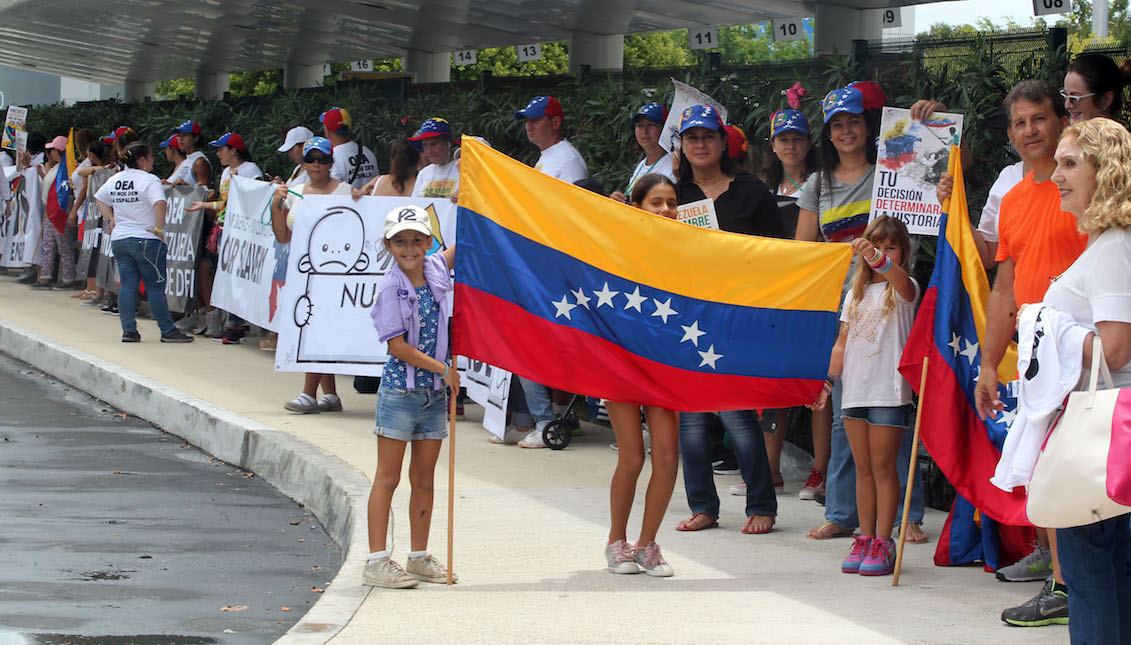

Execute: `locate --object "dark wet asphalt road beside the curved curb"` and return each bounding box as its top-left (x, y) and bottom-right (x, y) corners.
top-left (0, 354), bottom-right (340, 645)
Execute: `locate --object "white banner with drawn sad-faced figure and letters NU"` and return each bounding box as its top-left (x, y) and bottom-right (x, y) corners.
top-left (275, 195), bottom-right (456, 376)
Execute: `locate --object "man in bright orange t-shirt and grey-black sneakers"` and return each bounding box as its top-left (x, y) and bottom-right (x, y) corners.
top-left (974, 80), bottom-right (1087, 627)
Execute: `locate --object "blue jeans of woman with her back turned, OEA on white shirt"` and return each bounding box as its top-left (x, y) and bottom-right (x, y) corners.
top-left (110, 238), bottom-right (176, 335)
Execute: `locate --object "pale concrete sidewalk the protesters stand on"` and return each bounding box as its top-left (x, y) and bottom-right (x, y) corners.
top-left (0, 275), bottom-right (1068, 645)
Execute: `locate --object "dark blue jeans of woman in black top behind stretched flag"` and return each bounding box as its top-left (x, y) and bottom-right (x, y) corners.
top-left (680, 410), bottom-right (777, 519)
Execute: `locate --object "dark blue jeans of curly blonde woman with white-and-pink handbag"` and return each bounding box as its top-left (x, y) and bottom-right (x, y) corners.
top-left (1056, 515), bottom-right (1131, 645)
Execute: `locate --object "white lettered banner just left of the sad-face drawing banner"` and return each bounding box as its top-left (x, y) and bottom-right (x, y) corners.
top-left (211, 177), bottom-right (286, 332)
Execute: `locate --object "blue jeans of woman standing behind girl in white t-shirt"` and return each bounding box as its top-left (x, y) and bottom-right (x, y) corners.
top-left (824, 380), bottom-right (924, 528)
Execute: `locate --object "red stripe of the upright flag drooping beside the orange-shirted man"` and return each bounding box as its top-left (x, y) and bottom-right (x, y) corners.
top-left (900, 289), bottom-right (1029, 526)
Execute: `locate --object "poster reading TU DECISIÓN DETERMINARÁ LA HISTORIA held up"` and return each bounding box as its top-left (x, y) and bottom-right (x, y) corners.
top-left (870, 108), bottom-right (962, 235)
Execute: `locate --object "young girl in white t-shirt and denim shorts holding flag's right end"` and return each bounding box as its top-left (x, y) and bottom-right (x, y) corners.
top-left (814, 215), bottom-right (920, 576)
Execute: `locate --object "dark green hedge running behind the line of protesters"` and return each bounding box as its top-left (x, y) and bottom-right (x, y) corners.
top-left (28, 32), bottom-right (1064, 212)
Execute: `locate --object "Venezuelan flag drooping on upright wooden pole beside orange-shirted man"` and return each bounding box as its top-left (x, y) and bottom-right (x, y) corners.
top-left (899, 146), bottom-right (1034, 568)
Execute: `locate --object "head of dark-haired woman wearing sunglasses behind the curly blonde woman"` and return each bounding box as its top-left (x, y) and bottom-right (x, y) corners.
top-left (1061, 54), bottom-right (1131, 124)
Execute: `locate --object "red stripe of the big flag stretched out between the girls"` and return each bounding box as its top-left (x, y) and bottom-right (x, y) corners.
top-left (451, 284), bottom-right (821, 412)
